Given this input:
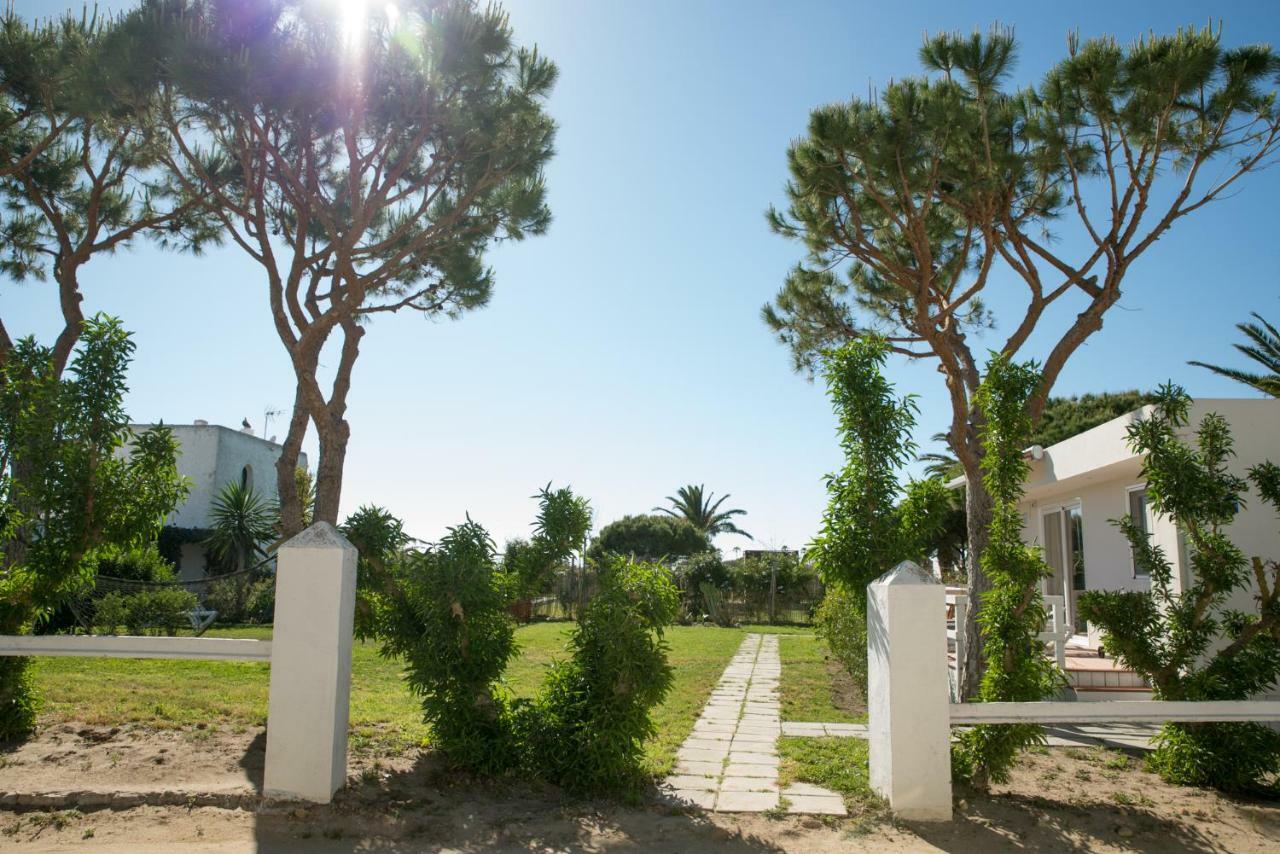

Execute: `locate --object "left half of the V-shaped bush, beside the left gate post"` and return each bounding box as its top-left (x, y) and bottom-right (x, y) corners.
top-left (375, 520), bottom-right (518, 773)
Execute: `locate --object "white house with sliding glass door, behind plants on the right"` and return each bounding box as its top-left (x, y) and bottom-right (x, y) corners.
top-left (1020, 398), bottom-right (1280, 630)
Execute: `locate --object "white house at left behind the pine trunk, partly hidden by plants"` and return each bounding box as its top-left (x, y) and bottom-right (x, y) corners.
top-left (129, 420), bottom-right (307, 579)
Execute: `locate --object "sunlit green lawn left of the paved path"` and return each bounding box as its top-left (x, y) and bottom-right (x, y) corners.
top-left (33, 622), bottom-right (744, 775)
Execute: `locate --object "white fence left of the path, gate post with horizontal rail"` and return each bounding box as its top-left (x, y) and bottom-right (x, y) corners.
top-left (0, 522), bottom-right (357, 804)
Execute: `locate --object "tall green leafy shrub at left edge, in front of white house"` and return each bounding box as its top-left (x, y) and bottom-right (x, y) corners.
top-left (0, 315), bottom-right (187, 739)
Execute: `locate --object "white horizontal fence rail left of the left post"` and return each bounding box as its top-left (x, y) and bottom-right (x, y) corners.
top-left (0, 635), bottom-right (271, 661)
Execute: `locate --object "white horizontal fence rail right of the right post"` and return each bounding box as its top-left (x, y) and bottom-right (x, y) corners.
top-left (951, 700), bottom-right (1280, 725)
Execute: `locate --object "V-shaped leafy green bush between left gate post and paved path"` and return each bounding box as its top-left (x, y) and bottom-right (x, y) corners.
top-left (370, 490), bottom-right (680, 795)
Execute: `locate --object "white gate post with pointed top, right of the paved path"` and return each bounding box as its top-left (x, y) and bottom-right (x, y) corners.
top-left (867, 561), bottom-right (951, 821)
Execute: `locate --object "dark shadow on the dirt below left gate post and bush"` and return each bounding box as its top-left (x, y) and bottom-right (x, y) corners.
top-left (241, 740), bottom-right (783, 854)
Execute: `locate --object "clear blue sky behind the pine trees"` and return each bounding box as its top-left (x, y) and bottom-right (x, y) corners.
top-left (10, 0), bottom-right (1280, 554)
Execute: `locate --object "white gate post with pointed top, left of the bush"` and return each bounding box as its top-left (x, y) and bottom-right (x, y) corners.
top-left (262, 522), bottom-right (356, 804)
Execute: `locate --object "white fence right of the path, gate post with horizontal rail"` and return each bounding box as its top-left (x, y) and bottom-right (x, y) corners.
top-left (867, 562), bottom-right (1280, 821)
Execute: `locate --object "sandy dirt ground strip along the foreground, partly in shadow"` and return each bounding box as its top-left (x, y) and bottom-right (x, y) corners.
top-left (0, 726), bottom-right (1280, 853)
